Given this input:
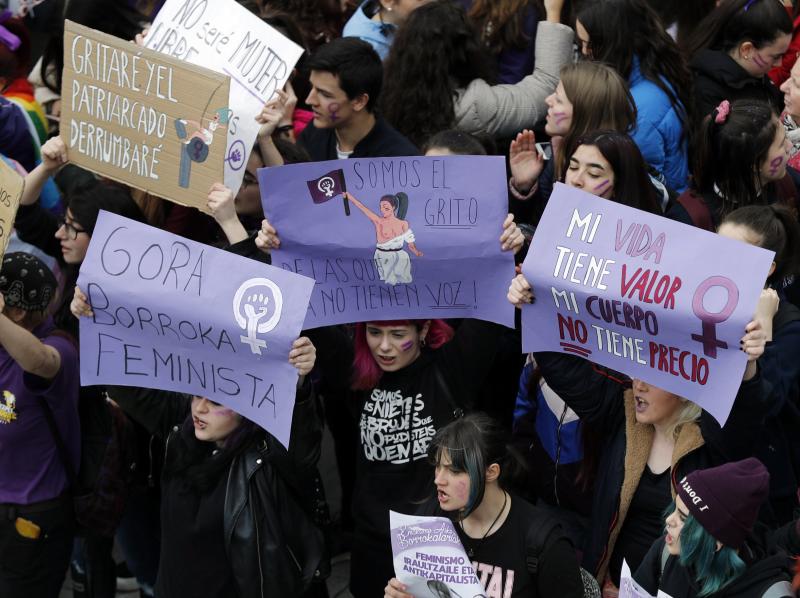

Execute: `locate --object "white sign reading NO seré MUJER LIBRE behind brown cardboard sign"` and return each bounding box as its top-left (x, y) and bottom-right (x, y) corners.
top-left (145, 0), bottom-right (303, 191)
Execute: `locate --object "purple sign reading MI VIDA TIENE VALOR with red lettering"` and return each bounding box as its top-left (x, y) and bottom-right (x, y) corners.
top-left (522, 184), bottom-right (773, 425)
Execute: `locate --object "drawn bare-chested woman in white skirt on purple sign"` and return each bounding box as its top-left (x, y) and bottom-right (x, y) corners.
top-left (345, 192), bottom-right (422, 285)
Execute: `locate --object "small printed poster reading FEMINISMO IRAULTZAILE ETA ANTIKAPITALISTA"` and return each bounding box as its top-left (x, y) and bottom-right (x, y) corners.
top-left (389, 511), bottom-right (486, 598)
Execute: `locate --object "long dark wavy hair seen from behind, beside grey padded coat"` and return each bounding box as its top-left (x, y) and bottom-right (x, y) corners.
top-left (381, 0), bottom-right (492, 147)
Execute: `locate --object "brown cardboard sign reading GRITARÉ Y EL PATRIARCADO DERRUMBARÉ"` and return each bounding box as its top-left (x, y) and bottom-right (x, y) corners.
top-left (61, 21), bottom-right (230, 211)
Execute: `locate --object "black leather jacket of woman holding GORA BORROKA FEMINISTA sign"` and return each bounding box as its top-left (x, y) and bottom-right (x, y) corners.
top-left (108, 381), bottom-right (327, 598)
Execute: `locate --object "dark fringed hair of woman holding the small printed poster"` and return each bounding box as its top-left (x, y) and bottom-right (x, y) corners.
top-left (428, 413), bottom-right (525, 519)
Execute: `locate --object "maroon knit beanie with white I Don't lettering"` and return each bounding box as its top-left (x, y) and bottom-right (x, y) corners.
top-left (678, 457), bottom-right (769, 548)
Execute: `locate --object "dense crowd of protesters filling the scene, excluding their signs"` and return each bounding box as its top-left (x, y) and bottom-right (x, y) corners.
top-left (0, 0), bottom-right (800, 598)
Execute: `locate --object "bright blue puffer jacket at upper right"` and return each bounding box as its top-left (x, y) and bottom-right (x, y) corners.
top-left (628, 57), bottom-right (689, 193)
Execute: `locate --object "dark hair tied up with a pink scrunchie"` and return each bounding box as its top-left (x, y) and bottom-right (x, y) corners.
top-left (694, 100), bottom-right (780, 216)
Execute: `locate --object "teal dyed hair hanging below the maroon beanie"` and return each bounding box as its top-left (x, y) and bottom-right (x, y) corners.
top-left (672, 502), bottom-right (747, 598)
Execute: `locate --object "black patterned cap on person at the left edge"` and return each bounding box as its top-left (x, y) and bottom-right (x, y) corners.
top-left (0, 251), bottom-right (58, 311)
